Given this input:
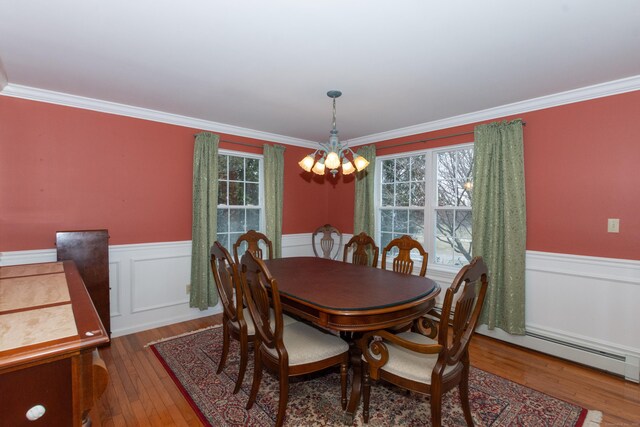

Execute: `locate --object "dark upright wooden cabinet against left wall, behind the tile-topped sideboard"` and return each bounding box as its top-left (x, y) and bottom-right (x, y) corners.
top-left (56, 230), bottom-right (111, 336)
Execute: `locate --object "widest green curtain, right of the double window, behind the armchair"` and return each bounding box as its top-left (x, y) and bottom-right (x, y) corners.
top-left (473, 119), bottom-right (527, 335)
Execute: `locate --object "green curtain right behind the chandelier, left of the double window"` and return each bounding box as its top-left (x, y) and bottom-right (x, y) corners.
top-left (353, 145), bottom-right (376, 239)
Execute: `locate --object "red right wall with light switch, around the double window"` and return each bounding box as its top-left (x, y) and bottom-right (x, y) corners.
top-left (360, 91), bottom-right (640, 260)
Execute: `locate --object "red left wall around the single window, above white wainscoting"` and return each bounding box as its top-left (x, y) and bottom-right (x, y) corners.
top-left (0, 96), bottom-right (338, 251)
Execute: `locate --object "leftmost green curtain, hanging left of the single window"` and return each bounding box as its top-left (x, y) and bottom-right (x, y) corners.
top-left (189, 132), bottom-right (220, 310)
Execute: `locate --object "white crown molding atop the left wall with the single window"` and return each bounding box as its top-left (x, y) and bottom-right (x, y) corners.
top-left (0, 84), bottom-right (318, 148)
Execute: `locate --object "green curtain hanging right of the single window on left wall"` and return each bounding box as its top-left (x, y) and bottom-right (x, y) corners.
top-left (263, 144), bottom-right (284, 258)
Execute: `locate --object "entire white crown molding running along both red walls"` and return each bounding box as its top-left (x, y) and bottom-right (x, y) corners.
top-left (0, 75), bottom-right (640, 149)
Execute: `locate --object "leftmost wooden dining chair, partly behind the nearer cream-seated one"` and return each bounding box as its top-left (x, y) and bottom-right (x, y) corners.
top-left (211, 241), bottom-right (296, 394)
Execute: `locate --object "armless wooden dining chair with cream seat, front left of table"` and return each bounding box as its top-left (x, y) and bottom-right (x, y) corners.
top-left (241, 252), bottom-right (349, 427)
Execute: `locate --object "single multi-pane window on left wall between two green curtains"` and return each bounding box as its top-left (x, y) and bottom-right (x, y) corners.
top-left (218, 150), bottom-right (264, 250)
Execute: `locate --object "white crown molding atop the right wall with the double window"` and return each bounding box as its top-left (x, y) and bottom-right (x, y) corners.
top-left (346, 75), bottom-right (640, 147)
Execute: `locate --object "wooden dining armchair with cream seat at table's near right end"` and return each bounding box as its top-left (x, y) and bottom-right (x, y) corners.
top-left (360, 257), bottom-right (488, 427)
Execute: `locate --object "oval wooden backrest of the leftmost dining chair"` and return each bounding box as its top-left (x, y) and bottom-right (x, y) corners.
top-left (211, 241), bottom-right (243, 322)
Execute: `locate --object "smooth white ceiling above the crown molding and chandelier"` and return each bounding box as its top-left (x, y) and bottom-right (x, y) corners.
top-left (0, 0), bottom-right (640, 145)
